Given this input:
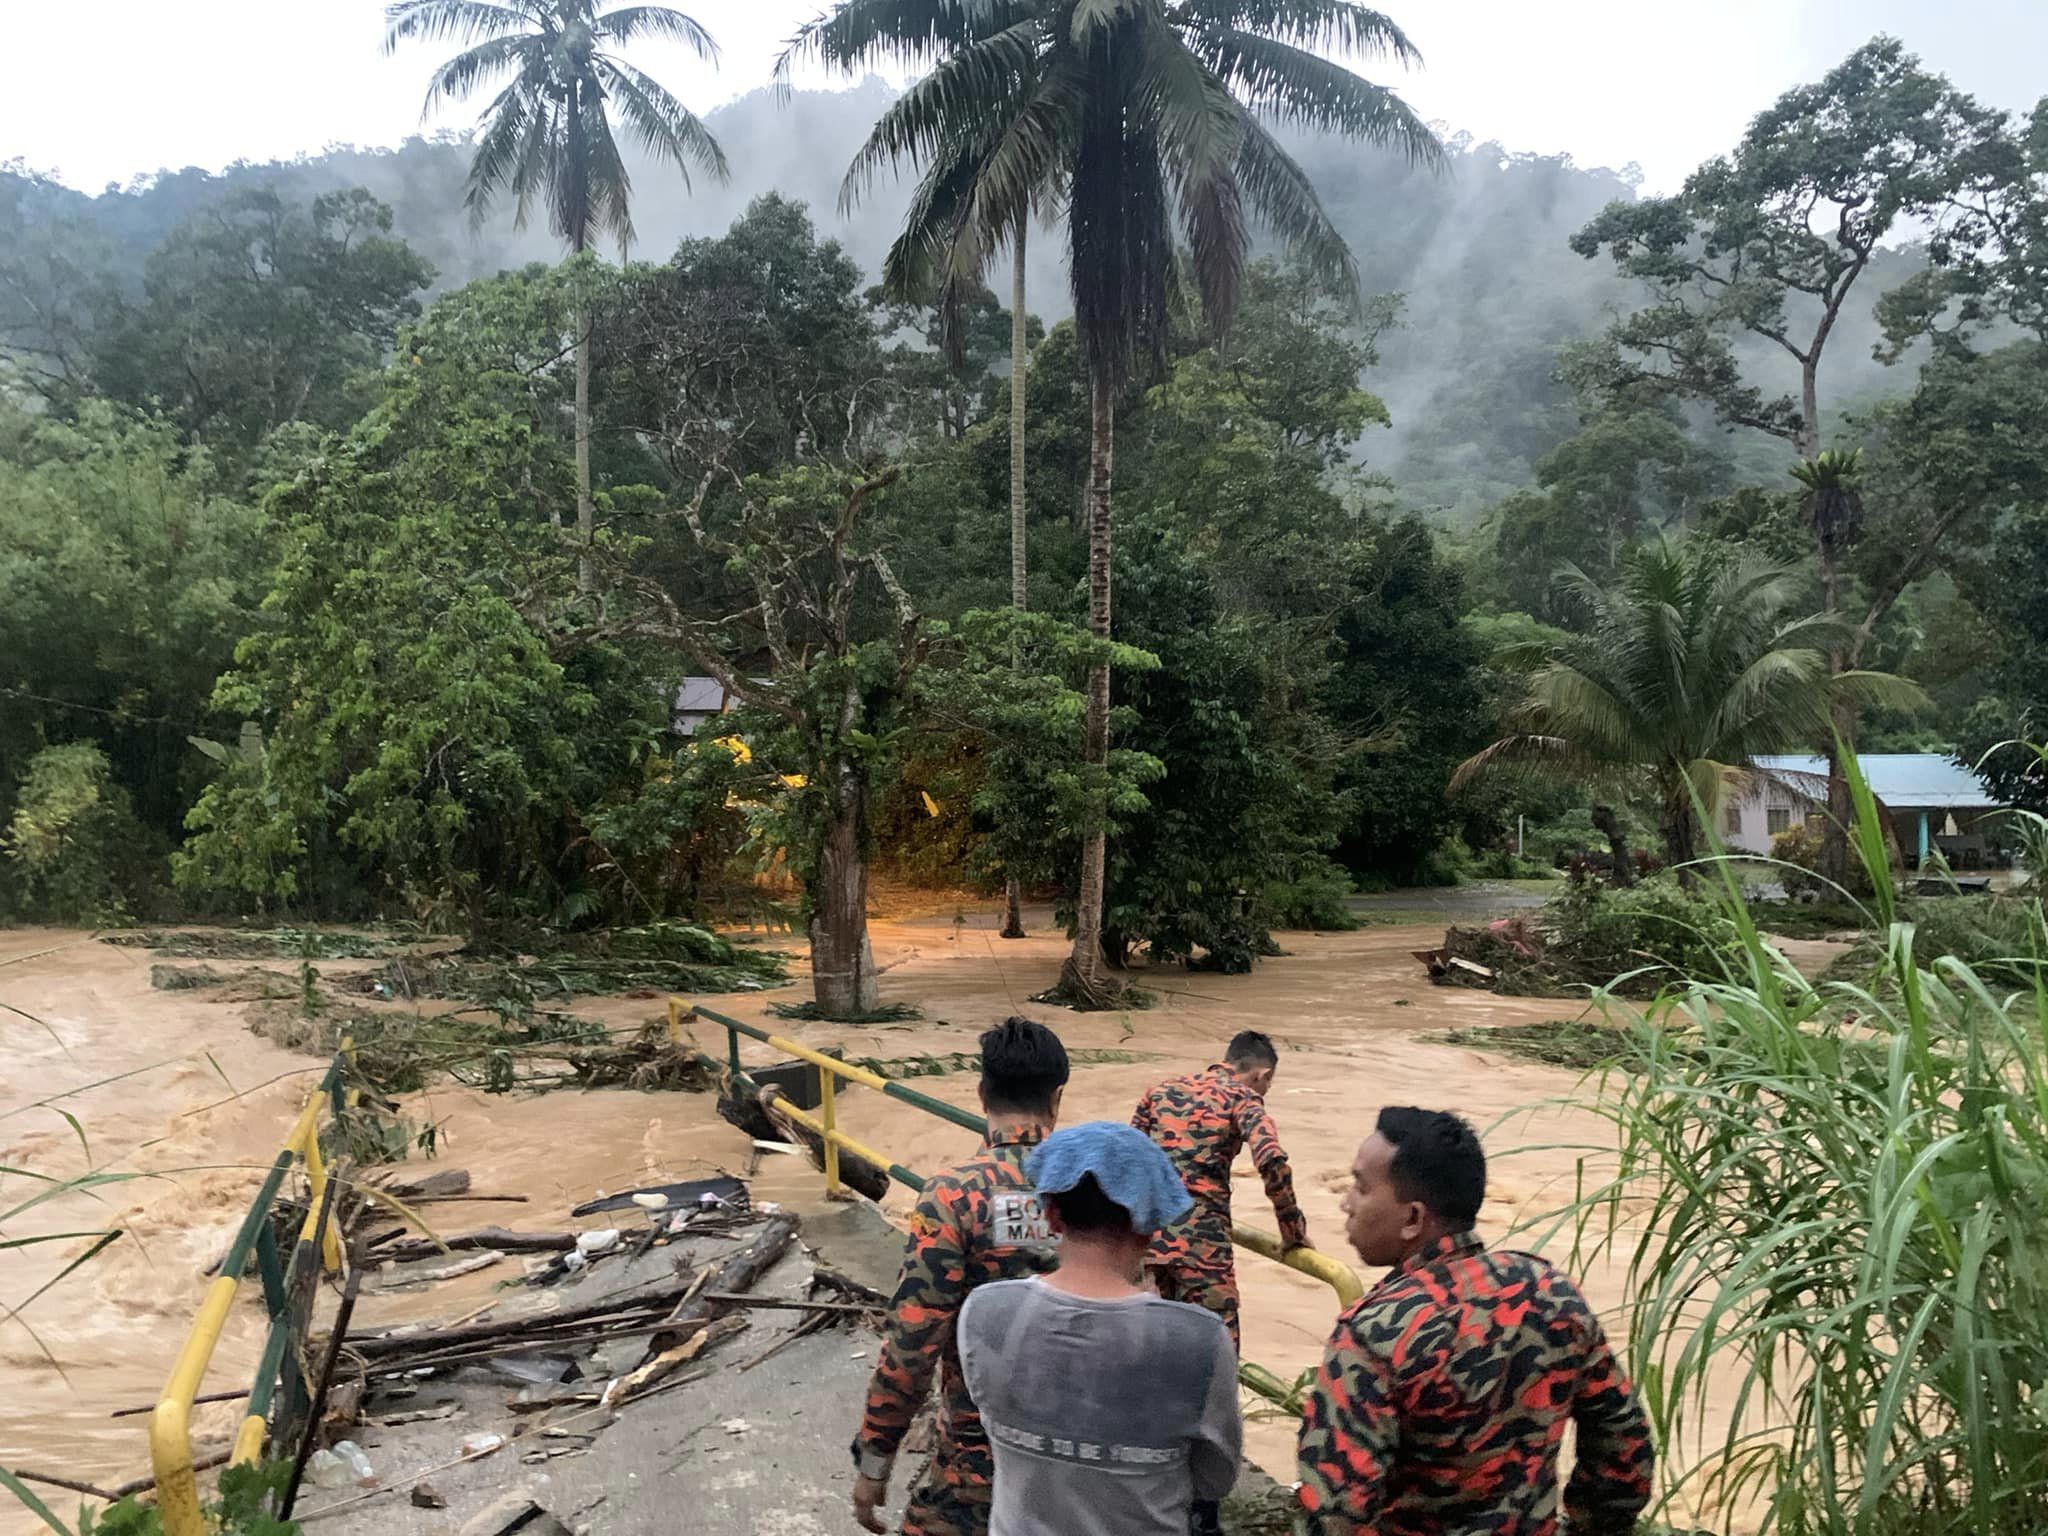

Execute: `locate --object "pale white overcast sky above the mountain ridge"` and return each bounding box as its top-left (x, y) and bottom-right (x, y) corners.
top-left (0, 0), bottom-right (2048, 190)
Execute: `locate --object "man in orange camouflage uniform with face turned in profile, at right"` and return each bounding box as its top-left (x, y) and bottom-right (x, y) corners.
top-left (1296, 1108), bottom-right (1655, 1536)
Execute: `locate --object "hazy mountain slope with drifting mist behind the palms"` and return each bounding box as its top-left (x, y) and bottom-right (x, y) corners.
top-left (0, 78), bottom-right (1909, 524)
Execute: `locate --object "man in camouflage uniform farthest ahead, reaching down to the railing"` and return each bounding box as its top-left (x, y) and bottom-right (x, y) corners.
top-left (1130, 1030), bottom-right (1309, 1536)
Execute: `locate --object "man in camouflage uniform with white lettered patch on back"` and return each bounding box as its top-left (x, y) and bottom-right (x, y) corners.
top-left (854, 1018), bottom-right (1067, 1536)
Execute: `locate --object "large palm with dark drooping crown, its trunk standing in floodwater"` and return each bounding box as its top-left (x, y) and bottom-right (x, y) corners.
top-left (791, 0), bottom-right (1442, 1001)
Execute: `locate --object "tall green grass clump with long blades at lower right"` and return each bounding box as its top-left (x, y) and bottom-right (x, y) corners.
top-left (1524, 758), bottom-right (2048, 1536)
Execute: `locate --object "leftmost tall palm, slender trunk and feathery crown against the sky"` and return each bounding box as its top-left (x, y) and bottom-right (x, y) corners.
top-left (385, 0), bottom-right (727, 590)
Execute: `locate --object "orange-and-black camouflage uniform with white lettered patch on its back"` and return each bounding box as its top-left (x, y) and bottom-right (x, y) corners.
top-left (854, 1126), bottom-right (1059, 1475)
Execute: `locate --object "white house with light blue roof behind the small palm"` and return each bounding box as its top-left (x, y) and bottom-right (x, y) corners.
top-left (1720, 752), bottom-right (2005, 868)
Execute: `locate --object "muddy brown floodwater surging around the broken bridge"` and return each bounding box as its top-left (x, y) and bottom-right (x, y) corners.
top-left (0, 905), bottom-right (1785, 1536)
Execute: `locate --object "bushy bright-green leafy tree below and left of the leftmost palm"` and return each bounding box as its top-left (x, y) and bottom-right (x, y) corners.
top-left (174, 453), bottom-right (630, 928)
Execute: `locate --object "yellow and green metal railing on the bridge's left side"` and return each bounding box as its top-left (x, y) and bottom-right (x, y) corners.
top-left (150, 1042), bottom-right (348, 1536)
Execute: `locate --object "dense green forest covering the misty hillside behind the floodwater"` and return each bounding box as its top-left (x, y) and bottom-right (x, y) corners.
top-left (0, 27), bottom-right (2048, 999)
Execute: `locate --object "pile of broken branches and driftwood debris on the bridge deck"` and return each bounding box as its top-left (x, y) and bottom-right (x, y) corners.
top-left (274, 1169), bottom-right (887, 1536)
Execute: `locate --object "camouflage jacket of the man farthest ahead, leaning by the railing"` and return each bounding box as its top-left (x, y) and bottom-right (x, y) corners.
top-left (1130, 1061), bottom-right (1309, 1247)
